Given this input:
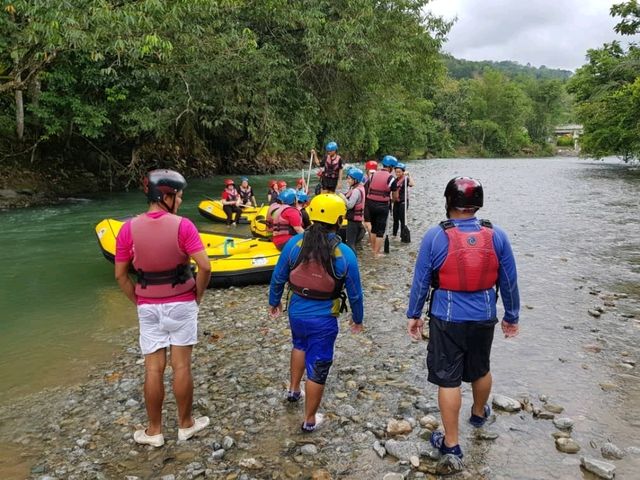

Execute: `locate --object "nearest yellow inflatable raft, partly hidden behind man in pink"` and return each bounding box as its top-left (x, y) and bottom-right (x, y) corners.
top-left (95, 218), bottom-right (280, 288)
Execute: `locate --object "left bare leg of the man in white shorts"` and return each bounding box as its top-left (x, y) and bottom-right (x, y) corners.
top-left (144, 348), bottom-right (167, 435)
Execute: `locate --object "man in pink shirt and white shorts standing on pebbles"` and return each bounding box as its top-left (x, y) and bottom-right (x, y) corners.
top-left (115, 170), bottom-right (211, 447)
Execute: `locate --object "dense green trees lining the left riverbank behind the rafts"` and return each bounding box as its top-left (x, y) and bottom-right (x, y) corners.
top-left (0, 0), bottom-right (571, 196)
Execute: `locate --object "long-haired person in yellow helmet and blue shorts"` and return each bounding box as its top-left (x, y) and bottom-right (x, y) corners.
top-left (269, 193), bottom-right (364, 432)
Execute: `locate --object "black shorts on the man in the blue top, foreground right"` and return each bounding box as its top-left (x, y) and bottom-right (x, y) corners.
top-left (427, 317), bottom-right (498, 388)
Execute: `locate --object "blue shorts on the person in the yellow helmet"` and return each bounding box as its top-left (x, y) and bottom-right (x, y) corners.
top-left (289, 316), bottom-right (338, 385)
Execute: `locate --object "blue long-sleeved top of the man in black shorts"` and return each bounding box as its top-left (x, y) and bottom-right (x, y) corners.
top-left (407, 217), bottom-right (520, 323)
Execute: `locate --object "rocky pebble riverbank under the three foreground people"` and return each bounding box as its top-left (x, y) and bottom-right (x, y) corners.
top-left (0, 244), bottom-right (640, 480)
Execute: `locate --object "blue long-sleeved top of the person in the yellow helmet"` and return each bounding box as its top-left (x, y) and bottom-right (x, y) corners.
top-left (269, 233), bottom-right (364, 324)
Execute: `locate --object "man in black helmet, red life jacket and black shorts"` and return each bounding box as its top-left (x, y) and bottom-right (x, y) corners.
top-left (407, 177), bottom-right (520, 458)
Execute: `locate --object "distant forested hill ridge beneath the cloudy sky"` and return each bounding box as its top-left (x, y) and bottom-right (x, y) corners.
top-left (444, 55), bottom-right (573, 80)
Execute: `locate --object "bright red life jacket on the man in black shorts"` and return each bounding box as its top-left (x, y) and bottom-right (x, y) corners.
top-left (433, 220), bottom-right (499, 292)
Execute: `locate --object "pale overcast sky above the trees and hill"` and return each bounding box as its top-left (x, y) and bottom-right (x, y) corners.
top-left (426, 0), bottom-right (638, 71)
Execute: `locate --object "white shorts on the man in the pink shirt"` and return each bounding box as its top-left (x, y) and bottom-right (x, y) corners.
top-left (138, 300), bottom-right (198, 355)
